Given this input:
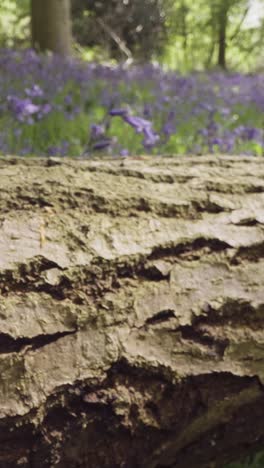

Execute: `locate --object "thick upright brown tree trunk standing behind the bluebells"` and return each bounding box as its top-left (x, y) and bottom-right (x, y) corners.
top-left (31, 0), bottom-right (72, 56)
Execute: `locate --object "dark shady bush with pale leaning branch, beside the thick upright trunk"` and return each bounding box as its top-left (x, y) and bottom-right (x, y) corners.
top-left (72, 0), bottom-right (175, 62)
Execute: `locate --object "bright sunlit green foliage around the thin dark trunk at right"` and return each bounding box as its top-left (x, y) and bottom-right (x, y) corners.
top-left (163, 0), bottom-right (264, 72)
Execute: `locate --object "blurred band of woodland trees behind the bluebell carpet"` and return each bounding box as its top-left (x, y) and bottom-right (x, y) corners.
top-left (0, 0), bottom-right (264, 71)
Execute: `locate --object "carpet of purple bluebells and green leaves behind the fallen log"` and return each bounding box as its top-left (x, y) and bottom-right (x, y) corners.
top-left (0, 50), bottom-right (264, 157)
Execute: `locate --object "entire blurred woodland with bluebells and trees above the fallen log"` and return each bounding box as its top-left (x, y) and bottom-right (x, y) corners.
top-left (0, 0), bottom-right (264, 157)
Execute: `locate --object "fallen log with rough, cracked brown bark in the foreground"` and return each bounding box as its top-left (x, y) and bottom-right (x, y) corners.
top-left (0, 156), bottom-right (264, 468)
